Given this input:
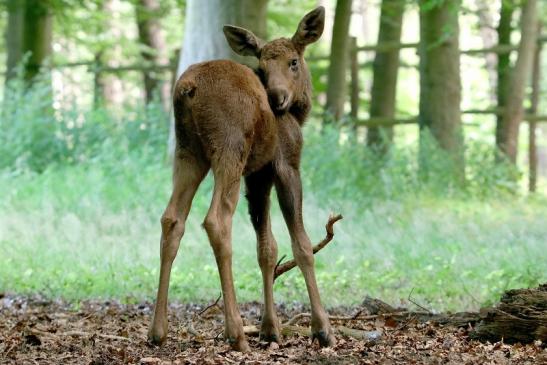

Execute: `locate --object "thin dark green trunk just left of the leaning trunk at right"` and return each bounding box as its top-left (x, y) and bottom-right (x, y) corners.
top-left (496, 0), bottom-right (515, 160)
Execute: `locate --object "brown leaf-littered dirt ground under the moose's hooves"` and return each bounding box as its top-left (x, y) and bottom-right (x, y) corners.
top-left (0, 295), bottom-right (547, 365)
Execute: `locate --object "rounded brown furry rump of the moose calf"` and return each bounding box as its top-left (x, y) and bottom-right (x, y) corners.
top-left (173, 60), bottom-right (277, 175)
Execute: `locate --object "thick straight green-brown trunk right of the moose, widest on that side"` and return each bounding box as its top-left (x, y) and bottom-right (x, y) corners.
top-left (419, 0), bottom-right (464, 178)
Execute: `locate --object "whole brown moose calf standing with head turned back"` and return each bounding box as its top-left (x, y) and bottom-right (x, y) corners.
top-left (149, 7), bottom-right (334, 351)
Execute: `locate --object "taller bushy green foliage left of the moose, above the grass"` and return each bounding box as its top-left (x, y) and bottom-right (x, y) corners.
top-left (0, 75), bottom-right (167, 172)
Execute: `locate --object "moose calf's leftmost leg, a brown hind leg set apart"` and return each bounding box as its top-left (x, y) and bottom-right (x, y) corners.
top-left (148, 156), bottom-right (208, 344)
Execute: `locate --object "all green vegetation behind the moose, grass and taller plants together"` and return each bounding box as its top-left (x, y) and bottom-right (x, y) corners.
top-left (0, 83), bottom-right (547, 310)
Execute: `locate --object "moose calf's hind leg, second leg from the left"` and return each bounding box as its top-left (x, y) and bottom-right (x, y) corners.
top-left (203, 160), bottom-right (250, 352)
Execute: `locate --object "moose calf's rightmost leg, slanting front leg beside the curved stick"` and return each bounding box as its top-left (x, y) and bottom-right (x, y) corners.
top-left (275, 165), bottom-right (335, 347)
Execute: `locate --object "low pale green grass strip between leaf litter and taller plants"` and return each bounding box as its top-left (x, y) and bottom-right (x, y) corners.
top-left (0, 144), bottom-right (547, 310)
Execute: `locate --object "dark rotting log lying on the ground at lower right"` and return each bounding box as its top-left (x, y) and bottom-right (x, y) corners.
top-left (470, 284), bottom-right (547, 343)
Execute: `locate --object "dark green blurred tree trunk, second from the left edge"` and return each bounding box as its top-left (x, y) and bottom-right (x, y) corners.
top-left (23, 0), bottom-right (53, 83)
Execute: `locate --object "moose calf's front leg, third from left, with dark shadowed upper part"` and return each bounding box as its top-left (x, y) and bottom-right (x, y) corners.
top-left (245, 165), bottom-right (280, 342)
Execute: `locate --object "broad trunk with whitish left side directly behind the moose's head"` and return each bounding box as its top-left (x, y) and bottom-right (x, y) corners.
top-left (168, 0), bottom-right (268, 157)
